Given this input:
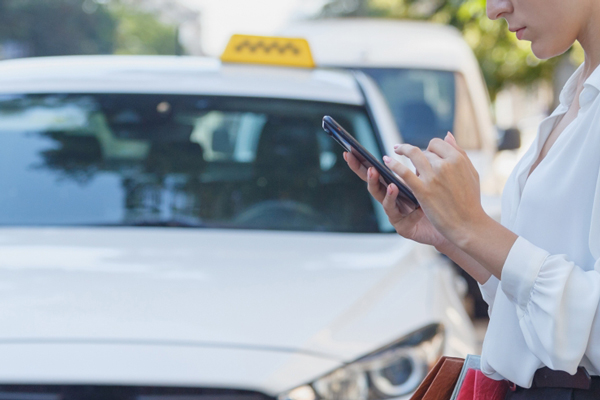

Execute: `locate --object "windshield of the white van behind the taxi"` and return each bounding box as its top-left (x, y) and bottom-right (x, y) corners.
top-left (361, 68), bottom-right (481, 150)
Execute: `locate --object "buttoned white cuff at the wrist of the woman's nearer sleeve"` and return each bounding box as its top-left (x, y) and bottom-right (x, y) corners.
top-left (501, 236), bottom-right (550, 309)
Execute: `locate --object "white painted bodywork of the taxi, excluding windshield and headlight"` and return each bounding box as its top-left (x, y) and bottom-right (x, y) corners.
top-left (0, 55), bottom-right (475, 398)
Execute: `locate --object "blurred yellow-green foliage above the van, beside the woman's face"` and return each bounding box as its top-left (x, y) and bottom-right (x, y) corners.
top-left (322, 0), bottom-right (583, 99)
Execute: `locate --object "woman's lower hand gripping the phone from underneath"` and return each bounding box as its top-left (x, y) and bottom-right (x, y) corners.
top-left (344, 152), bottom-right (451, 251)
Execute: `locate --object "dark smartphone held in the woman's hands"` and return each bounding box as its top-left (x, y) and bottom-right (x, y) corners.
top-left (323, 115), bottom-right (419, 214)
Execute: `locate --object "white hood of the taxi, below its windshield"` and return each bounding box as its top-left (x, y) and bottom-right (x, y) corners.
top-left (0, 227), bottom-right (450, 394)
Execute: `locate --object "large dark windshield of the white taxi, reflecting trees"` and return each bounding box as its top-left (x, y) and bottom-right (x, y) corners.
top-left (0, 94), bottom-right (389, 232)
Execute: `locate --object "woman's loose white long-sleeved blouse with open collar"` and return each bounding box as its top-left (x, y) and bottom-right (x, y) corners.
top-left (480, 66), bottom-right (600, 387)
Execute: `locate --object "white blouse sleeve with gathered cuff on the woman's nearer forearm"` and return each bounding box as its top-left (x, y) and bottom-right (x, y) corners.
top-left (501, 237), bottom-right (600, 374)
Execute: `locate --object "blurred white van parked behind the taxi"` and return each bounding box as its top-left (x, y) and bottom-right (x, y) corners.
top-left (281, 18), bottom-right (519, 203)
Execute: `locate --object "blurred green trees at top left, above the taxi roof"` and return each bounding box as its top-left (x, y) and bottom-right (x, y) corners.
top-left (0, 0), bottom-right (178, 56)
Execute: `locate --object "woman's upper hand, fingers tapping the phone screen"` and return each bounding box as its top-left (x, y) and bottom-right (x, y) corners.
top-left (384, 132), bottom-right (487, 247)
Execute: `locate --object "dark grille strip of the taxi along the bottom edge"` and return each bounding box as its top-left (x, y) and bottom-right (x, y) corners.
top-left (0, 385), bottom-right (275, 400)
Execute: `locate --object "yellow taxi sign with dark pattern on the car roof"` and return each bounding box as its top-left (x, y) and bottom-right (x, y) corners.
top-left (221, 35), bottom-right (315, 68)
